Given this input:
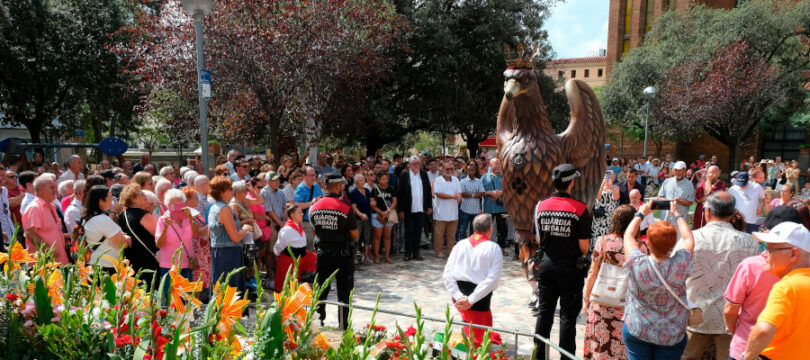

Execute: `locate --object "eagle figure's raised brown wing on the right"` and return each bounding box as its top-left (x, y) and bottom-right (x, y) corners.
top-left (559, 79), bottom-right (607, 208)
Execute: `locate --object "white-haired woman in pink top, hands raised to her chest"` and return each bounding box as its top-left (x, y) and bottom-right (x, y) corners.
top-left (155, 189), bottom-right (199, 292)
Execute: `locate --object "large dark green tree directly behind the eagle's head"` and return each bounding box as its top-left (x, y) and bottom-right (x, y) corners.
top-left (341, 0), bottom-right (568, 154)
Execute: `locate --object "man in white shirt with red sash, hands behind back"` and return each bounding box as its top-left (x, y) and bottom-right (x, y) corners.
top-left (443, 214), bottom-right (503, 346)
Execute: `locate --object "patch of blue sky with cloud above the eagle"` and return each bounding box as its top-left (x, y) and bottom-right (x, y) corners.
top-left (546, 0), bottom-right (610, 58)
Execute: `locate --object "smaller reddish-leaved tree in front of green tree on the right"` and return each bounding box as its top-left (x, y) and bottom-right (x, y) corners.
top-left (652, 42), bottom-right (784, 164)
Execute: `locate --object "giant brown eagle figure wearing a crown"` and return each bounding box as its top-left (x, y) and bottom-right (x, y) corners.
top-left (495, 46), bottom-right (607, 248)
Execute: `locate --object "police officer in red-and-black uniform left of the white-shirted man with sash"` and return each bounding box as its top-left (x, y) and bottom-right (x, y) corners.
top-left (309, 173), bottom-right (360, 330)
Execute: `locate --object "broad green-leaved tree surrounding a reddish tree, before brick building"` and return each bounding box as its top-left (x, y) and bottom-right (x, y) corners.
top-left (602, 0), bottom-right (810, 166)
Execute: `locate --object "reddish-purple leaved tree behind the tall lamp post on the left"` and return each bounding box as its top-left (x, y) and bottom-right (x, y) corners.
top-left (116, 0), bottom-right (400, 158)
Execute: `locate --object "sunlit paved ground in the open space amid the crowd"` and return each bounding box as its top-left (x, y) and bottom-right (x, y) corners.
top-left (318, 250), bottom-right (585, 359)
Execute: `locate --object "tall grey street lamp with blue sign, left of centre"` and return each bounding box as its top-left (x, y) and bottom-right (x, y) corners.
top-left (183, 0), bottom-right (214, 175)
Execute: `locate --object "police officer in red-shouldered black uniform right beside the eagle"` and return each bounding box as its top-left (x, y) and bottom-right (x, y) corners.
top-left (534, 164), bottom-right (592, 359)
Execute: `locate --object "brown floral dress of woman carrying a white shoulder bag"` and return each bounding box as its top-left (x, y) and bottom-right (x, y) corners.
top-left (583, 234), bottom-right (648, 360)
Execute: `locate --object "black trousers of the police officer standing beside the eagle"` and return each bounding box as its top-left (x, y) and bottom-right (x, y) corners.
top-left (534, 258), bottom-right (585, 360)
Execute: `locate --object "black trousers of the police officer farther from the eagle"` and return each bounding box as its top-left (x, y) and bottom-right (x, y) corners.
top-left (317, 250), bottom-right (354, 330)
